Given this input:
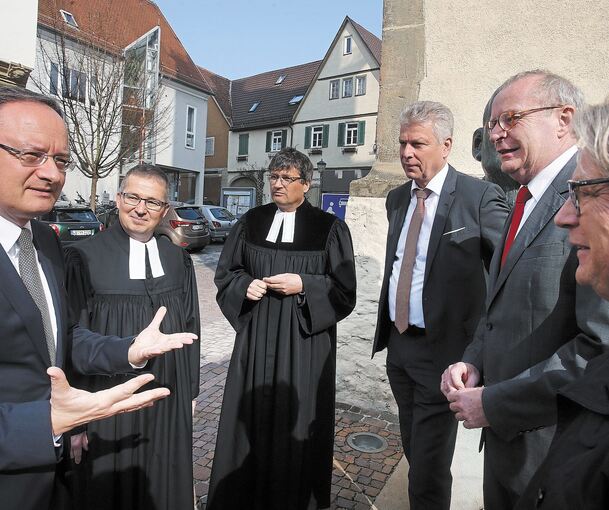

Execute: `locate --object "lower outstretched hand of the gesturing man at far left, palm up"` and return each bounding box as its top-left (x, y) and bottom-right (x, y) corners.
top-left (47, 367), bottom-right (169, 435)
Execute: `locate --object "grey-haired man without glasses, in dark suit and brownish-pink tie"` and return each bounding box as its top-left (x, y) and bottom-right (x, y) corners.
top-left (373, 101), bottom-right (508, 510)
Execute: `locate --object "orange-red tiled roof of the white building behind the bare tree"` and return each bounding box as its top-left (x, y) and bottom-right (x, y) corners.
top-left (38, 0), bottom-right (210, 92)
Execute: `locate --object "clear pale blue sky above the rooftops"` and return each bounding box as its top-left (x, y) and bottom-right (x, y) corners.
top-left (155, 0), bottom-right (383, 80)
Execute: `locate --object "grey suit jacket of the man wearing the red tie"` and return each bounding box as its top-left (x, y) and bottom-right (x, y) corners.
top-left (463, 156), bottom-right (609, 493)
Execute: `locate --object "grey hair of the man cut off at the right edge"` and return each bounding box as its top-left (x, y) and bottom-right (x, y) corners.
top-left (573, 97), bottom-right (609, 176)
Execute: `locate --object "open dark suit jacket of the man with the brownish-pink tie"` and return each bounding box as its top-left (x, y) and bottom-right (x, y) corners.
top-left (372, 166), bottom-right (509, 368)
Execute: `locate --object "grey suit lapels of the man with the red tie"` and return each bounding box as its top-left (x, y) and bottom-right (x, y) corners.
top-left (489, 156), bottom-right (577, 304)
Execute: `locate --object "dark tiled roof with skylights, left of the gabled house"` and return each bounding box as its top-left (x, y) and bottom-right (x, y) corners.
top-left (231, 60), bottom-right (321, 130)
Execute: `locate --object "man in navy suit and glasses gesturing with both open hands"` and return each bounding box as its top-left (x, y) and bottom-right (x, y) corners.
top-left (0, 88), bottom-right (195, 510)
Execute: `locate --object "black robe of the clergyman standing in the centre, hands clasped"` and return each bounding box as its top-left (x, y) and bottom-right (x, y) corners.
top-left (207, 201), bottom-right (355, 510)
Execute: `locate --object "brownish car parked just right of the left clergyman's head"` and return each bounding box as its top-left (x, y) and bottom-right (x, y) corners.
top-left (155, 205), bottom-right (211, 252)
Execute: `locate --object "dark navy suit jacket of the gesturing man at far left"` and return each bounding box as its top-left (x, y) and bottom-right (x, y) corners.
top-left (0, 221), bottom-right (131, 510)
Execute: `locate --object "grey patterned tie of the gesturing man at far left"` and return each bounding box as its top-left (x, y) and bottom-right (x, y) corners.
top-left (17, 228), bottom-right (55, 365)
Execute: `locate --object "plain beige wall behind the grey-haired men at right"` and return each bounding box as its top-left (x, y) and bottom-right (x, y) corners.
top-left (419, 0), bottom-right (609, 175)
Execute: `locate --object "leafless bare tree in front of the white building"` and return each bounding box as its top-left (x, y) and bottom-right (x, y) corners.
top-left (34, 13), bottom-right (170, 210)
